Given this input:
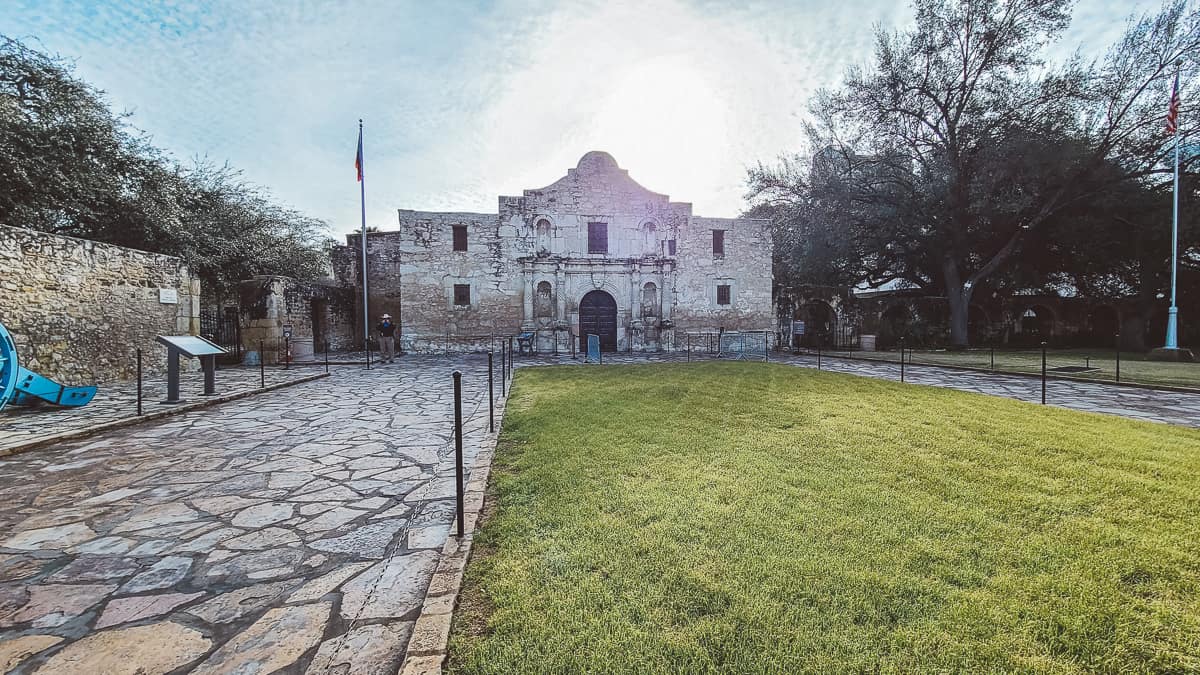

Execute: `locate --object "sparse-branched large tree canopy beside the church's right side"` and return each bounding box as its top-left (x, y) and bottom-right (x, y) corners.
top-left (749, 0), bottom-right (1200, 346)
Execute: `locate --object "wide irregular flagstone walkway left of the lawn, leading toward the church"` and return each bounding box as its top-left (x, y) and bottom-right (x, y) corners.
top-left (0, 356), bottom-right (500, 674)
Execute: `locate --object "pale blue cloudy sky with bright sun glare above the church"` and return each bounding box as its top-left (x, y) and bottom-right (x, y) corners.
top-left (0, 0), bottom-right (1158, 233)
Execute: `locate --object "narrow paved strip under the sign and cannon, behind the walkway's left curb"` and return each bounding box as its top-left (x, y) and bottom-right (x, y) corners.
top-left (0, 366), bottom-right (324, 454)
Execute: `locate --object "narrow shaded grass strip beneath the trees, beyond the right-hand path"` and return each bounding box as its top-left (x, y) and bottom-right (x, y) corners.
top-left (833, 348), bottom-right (1200, 388)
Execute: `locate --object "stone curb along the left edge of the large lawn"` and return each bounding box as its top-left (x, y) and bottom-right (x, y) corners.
top-left (398, 374), bottom-right (512, 675)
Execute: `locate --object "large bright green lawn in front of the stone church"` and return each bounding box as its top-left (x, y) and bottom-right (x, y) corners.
top-left (449, 363), bottom-right (1200, 673)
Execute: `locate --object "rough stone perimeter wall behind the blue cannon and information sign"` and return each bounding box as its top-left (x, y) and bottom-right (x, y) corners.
top-left (0, 226), bottom-right (200, 384)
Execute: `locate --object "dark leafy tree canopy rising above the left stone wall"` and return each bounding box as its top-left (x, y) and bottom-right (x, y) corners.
top-left (0, 36), bottom-right (328, 297)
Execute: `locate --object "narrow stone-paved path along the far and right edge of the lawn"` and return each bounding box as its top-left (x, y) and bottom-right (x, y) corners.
top-left (516, 352), bottom-right (1200, 428)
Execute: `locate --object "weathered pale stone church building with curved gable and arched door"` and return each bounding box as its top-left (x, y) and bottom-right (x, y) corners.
top-left (334, 151), bottom-right (775, 352)
